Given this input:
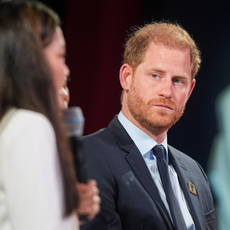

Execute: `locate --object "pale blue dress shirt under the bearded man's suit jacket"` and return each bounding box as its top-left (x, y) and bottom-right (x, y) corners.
top-left (118, 112), bottom-right (195, 230)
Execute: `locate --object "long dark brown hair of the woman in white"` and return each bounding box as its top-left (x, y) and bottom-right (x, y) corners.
top-left (0, 1), bottom-right (79, 216)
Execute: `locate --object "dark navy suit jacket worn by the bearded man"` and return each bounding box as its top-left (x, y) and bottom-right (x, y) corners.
top-left (81, 117), bottom-right (215, 230)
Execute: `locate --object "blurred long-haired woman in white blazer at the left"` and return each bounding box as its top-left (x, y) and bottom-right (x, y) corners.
top-left (0, 1), bottom-right (98, 230)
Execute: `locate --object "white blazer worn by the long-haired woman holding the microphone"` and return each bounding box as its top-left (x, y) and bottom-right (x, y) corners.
top-left (0, 109), bottom-right (78, 230)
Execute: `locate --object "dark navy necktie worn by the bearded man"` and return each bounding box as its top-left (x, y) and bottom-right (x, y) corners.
top-left (153, 145), bottom-right (187, 230)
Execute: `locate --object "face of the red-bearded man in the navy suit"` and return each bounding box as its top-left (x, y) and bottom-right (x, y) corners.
top-left (127, 42), bottom-right (195, 135)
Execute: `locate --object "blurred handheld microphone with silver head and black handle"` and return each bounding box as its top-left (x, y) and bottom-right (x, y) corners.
top-left (63, 107), bottom-right (88, 183)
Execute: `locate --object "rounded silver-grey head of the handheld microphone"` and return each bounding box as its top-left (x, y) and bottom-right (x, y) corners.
top-left (63, 106), bottom-right (85, 137)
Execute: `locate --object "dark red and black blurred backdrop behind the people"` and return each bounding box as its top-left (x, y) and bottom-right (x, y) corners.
top-left (39, 0), bottom-right (230, 172)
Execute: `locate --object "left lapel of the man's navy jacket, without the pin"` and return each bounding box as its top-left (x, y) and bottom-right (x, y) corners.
top-left (108, 117), bottom-right (173, 229)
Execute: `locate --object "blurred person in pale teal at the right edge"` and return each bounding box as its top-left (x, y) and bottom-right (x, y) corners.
top-left (208, 86), bottom-right (230, 230)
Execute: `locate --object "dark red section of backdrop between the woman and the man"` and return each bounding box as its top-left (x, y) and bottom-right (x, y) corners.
top-left (64, 0), bottom-right (142, 134)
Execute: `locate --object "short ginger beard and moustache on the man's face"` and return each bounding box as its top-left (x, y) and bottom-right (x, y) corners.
top-left (127, 84), bottom-right (185, 135)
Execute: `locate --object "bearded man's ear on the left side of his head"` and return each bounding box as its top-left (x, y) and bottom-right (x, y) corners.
top-left (120, 64), bottom-right (132, 90)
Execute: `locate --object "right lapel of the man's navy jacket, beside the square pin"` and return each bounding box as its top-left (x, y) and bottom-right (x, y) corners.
top-left (169, 146), bottom-right (205, 230)
